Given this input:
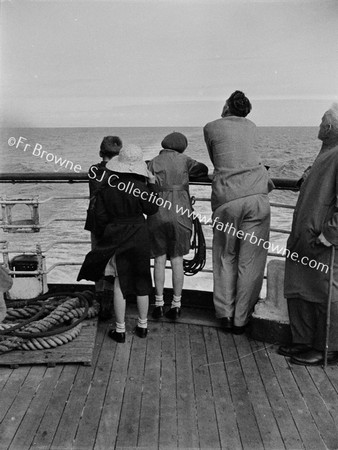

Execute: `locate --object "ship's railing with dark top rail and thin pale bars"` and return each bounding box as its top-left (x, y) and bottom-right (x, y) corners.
top-left (0, 173), bottom-right (298, 276)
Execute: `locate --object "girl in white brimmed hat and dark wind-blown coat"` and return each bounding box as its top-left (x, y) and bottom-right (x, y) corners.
top-left (78, 144), bottom-right (158, 342)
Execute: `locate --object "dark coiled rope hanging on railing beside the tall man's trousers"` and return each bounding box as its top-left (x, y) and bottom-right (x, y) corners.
top-left (183, 197), bottom-right (206, 276)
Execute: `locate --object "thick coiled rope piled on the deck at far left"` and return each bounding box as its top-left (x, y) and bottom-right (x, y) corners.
top-left (0, 291), bottom-right (99, 354)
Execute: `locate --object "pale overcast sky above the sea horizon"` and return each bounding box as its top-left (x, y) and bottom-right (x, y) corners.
top-left (0, 0), bottom-right (338, 127)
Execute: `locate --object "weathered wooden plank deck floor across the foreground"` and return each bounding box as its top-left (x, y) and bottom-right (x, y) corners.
top-left (0, 313), bottom-right (338, 450)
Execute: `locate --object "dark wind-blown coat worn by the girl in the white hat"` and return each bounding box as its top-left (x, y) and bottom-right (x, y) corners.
top-left (77, 172), bottom-right (158, 297)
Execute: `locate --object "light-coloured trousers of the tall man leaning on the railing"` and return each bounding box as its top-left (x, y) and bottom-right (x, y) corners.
top-left (213, 194), bottom-right (270, 326)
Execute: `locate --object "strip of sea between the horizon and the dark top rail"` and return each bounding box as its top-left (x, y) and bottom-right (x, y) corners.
top-left (0, 126), bottom-right (320, 177)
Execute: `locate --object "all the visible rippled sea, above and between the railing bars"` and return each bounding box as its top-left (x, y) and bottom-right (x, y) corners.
top-left (0, 127), bottom-right (321, 290)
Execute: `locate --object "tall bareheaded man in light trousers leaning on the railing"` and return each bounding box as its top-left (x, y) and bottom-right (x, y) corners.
top-left (204, 91), bottom-right (272, 334)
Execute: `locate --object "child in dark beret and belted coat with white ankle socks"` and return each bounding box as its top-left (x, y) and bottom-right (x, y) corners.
top-left (148, 132), bottom-right (208, 320)
